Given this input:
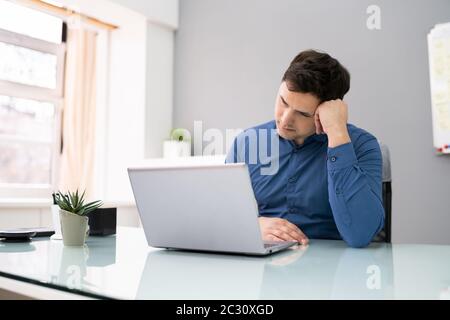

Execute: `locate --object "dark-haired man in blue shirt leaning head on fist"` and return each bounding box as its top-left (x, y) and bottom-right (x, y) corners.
top-left (226, 50), bottom-right (384, 247)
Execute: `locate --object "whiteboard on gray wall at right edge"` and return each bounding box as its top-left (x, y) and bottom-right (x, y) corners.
top-left (428, 23), bottom-right (450, 154)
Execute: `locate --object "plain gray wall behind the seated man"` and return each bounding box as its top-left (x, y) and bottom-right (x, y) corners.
top-left (173, 0), bottom-right (450, 244)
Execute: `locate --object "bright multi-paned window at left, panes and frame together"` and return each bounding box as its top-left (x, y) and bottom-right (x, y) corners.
top-left (0, 0), bottom-right (65, 198)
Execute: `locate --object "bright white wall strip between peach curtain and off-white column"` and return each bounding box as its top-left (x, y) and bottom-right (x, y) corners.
top-left (103, 17), bottom-right (147, 201)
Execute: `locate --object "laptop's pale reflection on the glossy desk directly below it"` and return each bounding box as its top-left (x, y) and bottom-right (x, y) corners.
top-left (136, 245), bottom-right (299, 300)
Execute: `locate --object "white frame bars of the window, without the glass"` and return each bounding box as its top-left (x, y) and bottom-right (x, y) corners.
top-left (0, 27), bottom-right (66, 198)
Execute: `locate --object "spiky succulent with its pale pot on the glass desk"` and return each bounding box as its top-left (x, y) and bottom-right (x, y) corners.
top-left (55, 190), bottom-right (103, 246)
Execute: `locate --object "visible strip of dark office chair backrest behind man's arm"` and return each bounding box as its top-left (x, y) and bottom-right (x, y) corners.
top-left (374, 141), bottom-right (392, 243)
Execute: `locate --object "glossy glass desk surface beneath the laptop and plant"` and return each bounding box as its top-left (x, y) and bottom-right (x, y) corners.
top-left (0, 227), bottom-right (450, 300)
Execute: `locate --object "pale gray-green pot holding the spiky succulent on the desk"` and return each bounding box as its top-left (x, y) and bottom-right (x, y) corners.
top-left (59, 209), bottom-right (89, 247)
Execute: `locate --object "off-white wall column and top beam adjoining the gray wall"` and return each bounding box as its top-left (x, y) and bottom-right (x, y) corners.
top-left (110, 0), bottom-right (179, 158)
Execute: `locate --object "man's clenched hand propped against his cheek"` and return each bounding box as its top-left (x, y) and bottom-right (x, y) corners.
top-left (314, 99), bottom-right (350, 148)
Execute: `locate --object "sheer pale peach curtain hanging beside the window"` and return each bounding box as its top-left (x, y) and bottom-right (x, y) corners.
top-left (59, 26), bottom-right (96, 198)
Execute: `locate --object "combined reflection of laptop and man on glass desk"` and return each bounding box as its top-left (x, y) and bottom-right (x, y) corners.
top-left (136, 241), bottom-right (393, 299)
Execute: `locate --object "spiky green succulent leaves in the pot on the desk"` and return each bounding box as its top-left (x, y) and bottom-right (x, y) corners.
top-left (53, 190), bottom-right (103, 216)
